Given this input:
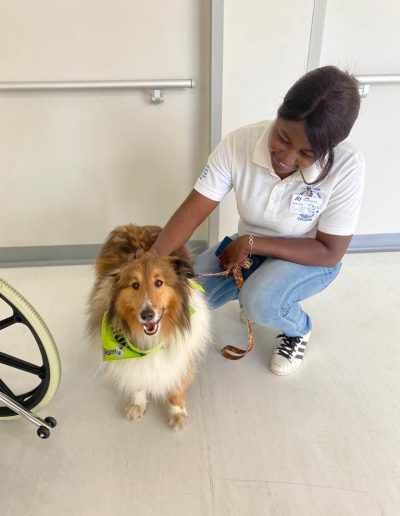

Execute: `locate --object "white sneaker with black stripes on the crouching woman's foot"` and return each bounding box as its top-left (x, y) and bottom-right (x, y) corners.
top-left (269, 332), bottom-right (311, 375)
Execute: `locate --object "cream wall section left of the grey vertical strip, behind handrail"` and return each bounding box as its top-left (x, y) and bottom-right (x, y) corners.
top-left (0, 0), bottom-right (210, 247)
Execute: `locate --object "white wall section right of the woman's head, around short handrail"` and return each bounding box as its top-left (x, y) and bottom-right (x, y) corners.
top-left (321, 0), bottom-right (400, 234)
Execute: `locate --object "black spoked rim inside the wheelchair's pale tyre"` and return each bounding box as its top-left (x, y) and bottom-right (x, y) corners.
top-left (0, 294), bottom-right (50, 417)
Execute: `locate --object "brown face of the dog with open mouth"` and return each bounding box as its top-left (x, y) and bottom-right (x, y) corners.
top-left (110, 253), bottom-right (193, 338)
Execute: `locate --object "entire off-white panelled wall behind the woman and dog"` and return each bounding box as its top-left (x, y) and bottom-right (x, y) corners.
top-left (0, 0), bottom-right (400, 247)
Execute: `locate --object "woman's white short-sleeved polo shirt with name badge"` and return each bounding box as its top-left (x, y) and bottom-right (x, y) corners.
top-left (194, 121), bottom-right (365, 238)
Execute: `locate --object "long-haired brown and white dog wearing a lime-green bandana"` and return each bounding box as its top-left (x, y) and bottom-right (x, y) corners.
top-left (88, 224), bottom-right (210, 430)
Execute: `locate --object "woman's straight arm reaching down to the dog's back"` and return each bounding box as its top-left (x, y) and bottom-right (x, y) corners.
top-left (150, 190), bottom-right (219, 256)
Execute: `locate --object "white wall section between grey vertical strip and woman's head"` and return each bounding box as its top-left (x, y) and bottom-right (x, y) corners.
top-left (219, 0), bottom-right (313, 237)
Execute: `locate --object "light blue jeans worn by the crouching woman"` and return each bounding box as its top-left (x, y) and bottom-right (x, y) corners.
top-left (194, 235), bottom-right (341, 337)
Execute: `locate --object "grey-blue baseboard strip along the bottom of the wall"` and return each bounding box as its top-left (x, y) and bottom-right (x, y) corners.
top-left (0, 233), bottom-right (400, 268)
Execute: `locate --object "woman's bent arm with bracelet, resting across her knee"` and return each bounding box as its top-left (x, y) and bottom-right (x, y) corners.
top-left (220, 231), bottom-right (352, 269)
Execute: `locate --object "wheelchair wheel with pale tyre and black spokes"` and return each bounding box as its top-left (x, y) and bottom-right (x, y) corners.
top-left (0, 278), bottom-right (61, 419)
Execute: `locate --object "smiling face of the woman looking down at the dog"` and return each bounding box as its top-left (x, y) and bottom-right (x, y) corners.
top-left (268, 118), bottom-right (316, 177)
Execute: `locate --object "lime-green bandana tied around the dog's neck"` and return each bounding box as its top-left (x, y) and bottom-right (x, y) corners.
top-left (101, 280), bottom-right (204, 362)
